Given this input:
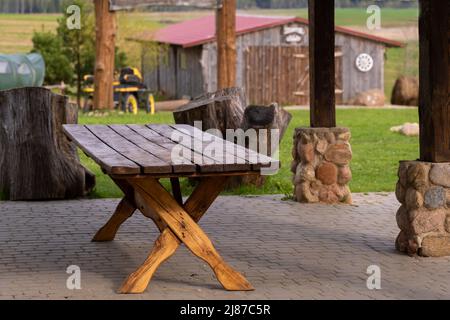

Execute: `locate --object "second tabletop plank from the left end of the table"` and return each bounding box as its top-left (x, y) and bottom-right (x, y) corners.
top-left (86, 125), bottom-right (172, 173)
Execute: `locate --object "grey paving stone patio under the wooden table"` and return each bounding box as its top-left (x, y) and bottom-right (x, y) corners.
top-left (0, 193), bottom-right (450, 299)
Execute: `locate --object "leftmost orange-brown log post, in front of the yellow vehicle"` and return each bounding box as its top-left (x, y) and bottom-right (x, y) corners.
top-left (94, 0), bottom-right (116, 109)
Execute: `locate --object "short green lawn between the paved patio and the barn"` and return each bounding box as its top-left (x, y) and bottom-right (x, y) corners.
top-left (80, 108), bottom-right (419, 198)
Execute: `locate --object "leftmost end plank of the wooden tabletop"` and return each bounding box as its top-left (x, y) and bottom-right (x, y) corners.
top-left (63, 124), bottom-right (141, 175)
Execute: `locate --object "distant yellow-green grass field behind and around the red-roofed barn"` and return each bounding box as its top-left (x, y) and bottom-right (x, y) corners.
top-left (0, 9), bottom-right (418, 101)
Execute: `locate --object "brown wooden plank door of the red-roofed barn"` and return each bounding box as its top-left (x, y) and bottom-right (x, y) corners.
top-left (245, 46), bottom-right (343, 105)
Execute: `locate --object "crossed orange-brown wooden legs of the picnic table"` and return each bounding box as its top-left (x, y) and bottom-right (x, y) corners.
top-left (93, 177), bottom-right (253, 293)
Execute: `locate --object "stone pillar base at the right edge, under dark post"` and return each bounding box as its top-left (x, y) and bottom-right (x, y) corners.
top-left (395, 161), bottom-right (450, 257)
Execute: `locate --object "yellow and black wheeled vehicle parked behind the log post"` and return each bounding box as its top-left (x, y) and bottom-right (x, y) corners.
top-left (83, 67), bottom-right (155, 114)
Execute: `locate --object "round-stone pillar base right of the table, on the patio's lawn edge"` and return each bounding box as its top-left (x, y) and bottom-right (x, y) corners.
top-left (291, 128), bottom-right (352, 204)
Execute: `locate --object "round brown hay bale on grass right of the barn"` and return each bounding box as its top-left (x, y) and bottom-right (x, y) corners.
top-left (391, 76), bottom-right (419, 106)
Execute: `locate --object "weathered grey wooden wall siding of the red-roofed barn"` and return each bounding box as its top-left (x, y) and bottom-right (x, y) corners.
top-left (143, 23), bottom-right (385, 102)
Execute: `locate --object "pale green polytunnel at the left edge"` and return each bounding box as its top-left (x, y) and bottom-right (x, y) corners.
top-left (0, 53), bottom-right (45, 90)
